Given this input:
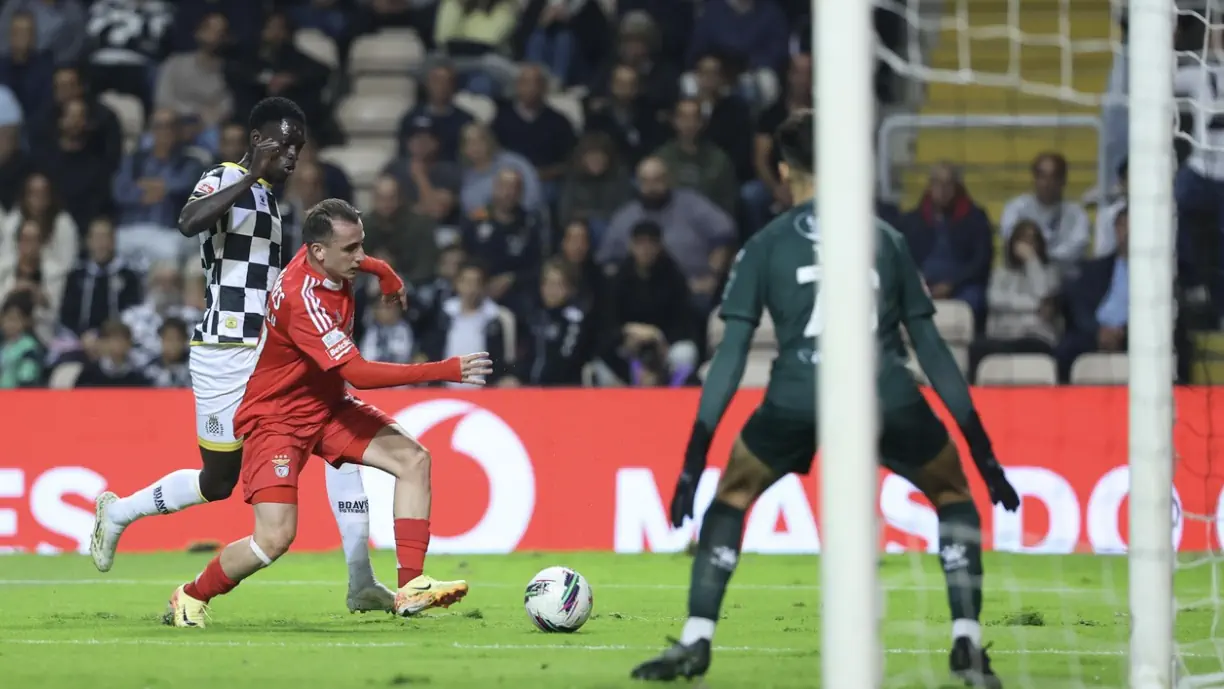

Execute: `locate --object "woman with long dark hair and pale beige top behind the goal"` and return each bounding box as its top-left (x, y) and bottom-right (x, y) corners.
top-left (969, 218), bottom-right (1061, 381)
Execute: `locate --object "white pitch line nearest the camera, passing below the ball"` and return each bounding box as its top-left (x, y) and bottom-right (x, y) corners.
top-left (0, 631), bottom-right (1217, 657)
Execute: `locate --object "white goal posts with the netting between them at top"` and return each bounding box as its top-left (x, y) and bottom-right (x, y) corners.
top-left (813, 0), bottom-right (1179, 689)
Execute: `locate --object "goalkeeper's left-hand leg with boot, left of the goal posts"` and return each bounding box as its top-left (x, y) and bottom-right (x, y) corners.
top-left (633, 433), bottom-right (778, 680)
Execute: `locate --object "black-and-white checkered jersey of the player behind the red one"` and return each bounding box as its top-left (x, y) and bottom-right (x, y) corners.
top-left (191, 163), bottom-right (282, 346)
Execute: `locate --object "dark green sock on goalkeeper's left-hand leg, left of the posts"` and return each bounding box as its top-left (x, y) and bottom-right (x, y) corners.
top-left (689, 499), bottom-right (744, 620)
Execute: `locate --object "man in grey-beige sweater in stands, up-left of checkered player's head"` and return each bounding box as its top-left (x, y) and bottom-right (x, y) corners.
top-left (154, 12), bottom-right (233, 153)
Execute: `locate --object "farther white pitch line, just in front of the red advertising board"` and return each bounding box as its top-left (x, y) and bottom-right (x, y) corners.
top-left (0, 579), bottom-right (1116, 595)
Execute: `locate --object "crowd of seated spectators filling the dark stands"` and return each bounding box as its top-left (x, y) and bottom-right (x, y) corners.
top-left (0, 0), bottom-right (1155, 388)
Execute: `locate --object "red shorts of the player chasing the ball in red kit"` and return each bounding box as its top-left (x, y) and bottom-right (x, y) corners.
top-left (242, 398), bottom-right (395, 504)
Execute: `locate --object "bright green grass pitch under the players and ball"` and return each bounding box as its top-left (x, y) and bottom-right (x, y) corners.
top-left (0, 552), bottom-right (1224, 689)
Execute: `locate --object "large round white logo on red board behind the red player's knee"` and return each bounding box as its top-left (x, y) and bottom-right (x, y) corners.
top-left (362, 399), bottom-right (536, 553)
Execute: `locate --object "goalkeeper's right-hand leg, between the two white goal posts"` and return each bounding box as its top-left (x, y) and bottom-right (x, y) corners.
top-left (905, 442), bottom-right (1001, 687)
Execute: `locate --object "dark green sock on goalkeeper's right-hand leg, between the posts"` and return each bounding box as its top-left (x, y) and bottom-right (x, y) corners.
top-left (938, 502), bottom-right (982, 627)
